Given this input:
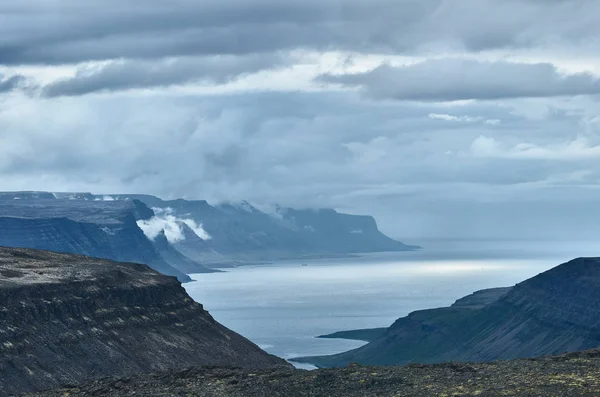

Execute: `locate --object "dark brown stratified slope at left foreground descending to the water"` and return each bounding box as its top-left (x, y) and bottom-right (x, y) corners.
top-left (0, 248), bottom-right (286, 395)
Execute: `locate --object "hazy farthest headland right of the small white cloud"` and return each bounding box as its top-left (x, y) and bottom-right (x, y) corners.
top-left (109, 195), bottom-right (419, 263)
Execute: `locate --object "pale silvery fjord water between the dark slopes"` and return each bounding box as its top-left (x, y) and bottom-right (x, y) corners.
top-left (185, 240), bottom-right (600, 366)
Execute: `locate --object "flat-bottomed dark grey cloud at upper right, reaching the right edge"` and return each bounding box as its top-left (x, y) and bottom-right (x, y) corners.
top-left (317, 59), bottom-right (600, 101)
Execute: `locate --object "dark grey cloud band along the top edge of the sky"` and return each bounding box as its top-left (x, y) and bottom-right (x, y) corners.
top-left (0, 0), bottom-right (600, 65)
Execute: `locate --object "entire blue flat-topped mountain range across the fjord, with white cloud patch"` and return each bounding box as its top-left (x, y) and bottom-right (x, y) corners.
top-left (0, 192), bottom-right (418, 281)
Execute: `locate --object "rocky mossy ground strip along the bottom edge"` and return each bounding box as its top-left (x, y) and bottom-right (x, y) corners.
top-left (35, 350), bottom-right (600, 397)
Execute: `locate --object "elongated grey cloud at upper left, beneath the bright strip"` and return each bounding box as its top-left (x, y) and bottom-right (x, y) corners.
top-left (42, 54), bottom-right (290, 97)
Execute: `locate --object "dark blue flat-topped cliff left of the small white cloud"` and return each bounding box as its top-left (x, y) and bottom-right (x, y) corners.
top-left (0, 195), bottom-right (195, 281)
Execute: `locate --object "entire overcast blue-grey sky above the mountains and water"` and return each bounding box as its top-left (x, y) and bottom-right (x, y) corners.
top-left (0, 0), bottom-right (600, 243)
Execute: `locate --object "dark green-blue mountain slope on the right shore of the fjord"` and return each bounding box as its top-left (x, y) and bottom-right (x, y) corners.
top-left (301, 258), bottom-right (600, 367)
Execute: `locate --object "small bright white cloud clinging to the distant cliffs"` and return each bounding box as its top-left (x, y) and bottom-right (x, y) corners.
top-left (137, 208), bottom-right (211, 243)
